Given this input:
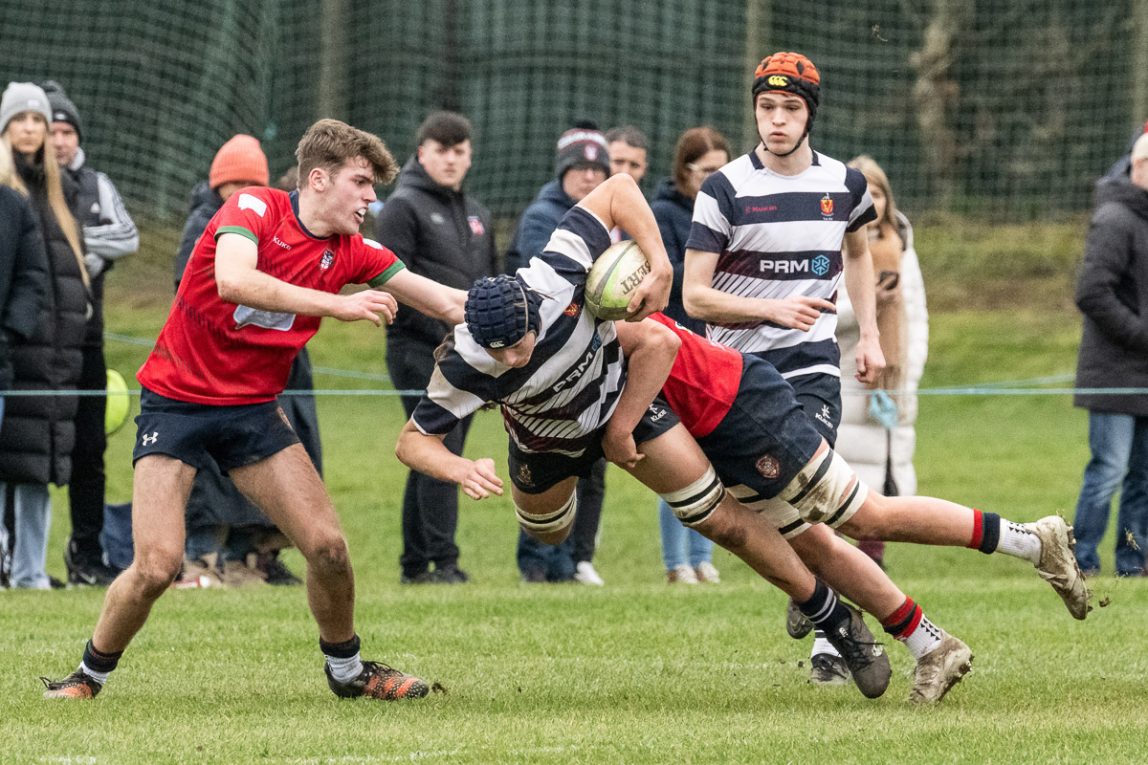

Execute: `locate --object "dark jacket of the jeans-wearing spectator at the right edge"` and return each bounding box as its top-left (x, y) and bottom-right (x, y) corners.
top-left (1076, 177), bottom-right (1148, 417)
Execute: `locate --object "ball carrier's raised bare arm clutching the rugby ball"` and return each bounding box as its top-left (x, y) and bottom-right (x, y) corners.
top-left (579, 172), bottom-right (674, 322)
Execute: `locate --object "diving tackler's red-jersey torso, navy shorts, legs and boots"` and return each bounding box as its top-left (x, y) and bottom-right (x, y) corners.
top-left (622, 314), bottom-right (1089, 703)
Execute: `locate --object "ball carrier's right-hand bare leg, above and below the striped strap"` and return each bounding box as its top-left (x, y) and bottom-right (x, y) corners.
top-left (629, 425), bottom-right (816, 603)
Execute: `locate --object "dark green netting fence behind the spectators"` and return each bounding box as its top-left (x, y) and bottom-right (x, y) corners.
top-left (0, 0), bottom-right (1148, 221)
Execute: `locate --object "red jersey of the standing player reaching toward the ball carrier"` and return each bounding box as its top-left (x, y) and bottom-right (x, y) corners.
top-left (135, 187), bottom-right (404, 405)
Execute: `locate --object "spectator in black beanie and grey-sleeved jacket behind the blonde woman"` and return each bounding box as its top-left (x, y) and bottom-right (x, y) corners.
top-left (44, 80), bottom-right (140, 586)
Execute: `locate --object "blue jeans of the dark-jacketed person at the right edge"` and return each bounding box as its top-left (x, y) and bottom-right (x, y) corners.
top-left (1072, 411), bottom-right (1148, 575)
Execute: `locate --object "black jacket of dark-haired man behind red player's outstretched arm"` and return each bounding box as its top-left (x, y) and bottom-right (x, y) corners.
top-left (374, 157), bottom-right (497, 347)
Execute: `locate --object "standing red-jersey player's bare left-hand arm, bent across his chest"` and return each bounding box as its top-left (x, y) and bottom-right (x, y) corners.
top-left (215, 227), bottom-right (398, 326)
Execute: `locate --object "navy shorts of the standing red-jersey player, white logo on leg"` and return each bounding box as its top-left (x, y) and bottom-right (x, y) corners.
top-left (132, 388), bottom-right (300, 473)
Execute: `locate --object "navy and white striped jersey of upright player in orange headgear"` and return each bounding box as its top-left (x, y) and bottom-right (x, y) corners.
top-left (685, 152), bottom-right (876, 377)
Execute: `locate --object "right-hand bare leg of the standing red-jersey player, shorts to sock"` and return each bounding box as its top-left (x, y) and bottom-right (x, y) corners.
top-left (230, 443), bottom-right (355, 643)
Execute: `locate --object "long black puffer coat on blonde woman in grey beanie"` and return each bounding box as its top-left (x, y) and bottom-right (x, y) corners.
top-left (0, 154), bottom-right (90, 486)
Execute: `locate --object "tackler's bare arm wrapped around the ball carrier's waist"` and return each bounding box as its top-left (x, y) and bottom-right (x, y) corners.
top-left (602, 319), bottom-right (682, 468)
